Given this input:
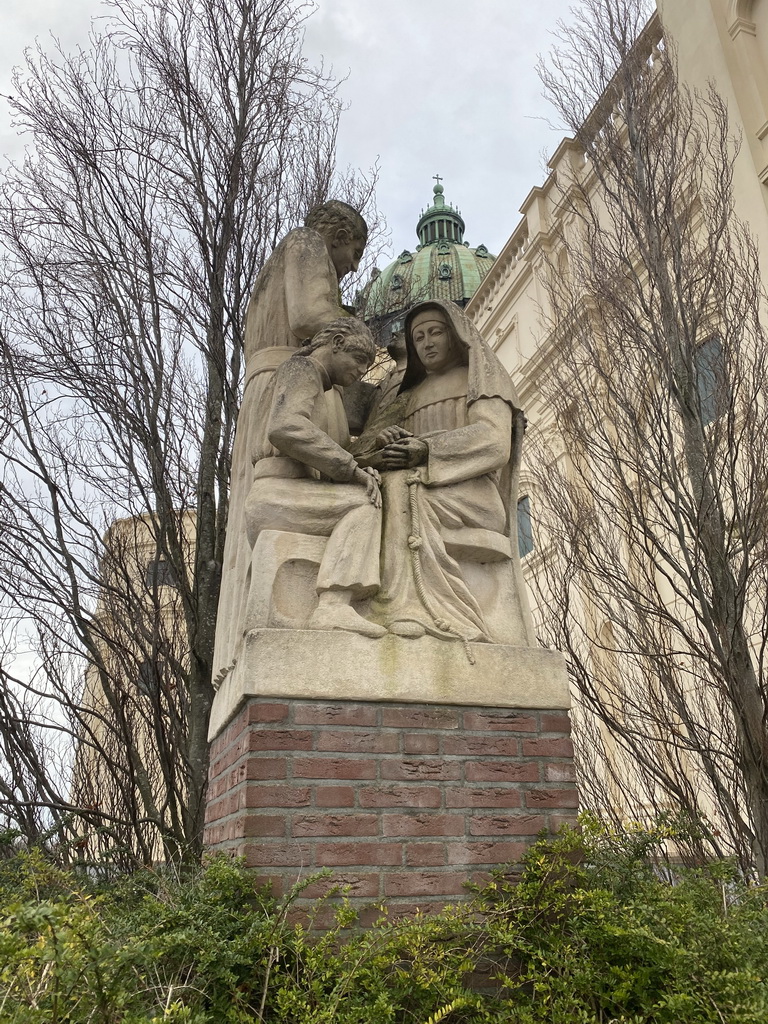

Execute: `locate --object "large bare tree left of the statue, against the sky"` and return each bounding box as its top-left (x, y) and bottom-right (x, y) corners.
top-left (0, 0), bottom-right (376, 860)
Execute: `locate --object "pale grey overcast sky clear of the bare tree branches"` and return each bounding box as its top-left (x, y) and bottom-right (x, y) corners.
top-left (0, 0), bottom-right (573, 264)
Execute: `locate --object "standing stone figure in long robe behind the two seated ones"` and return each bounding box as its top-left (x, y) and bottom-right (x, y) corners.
top-left (214, 200), bottom-right (368, 680)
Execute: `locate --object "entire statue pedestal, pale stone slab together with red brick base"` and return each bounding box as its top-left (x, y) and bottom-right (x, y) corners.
top-left (206, 629), bottom-right (578, 927)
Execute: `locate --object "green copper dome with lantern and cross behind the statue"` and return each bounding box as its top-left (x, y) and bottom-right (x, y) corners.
top-left (358, 177), bottom-right (496, 344)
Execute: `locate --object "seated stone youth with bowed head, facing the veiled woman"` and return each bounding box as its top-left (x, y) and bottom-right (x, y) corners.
top-left (245, 317), bottom-right (386, 638)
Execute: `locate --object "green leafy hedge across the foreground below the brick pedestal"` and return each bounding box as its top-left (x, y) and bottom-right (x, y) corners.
top-left (0, 818), bottom-right (768, 1024)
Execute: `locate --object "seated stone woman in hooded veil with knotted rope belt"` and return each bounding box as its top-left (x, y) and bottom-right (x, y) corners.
top-left (357, 301), bottom-right (532, 644)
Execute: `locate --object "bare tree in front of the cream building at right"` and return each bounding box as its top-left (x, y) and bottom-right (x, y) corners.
top-left (531, 0), bottom-right (768, 874)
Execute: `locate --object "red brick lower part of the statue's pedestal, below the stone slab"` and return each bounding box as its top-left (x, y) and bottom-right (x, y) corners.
top-left (206, 697), bottom-right (578, 912)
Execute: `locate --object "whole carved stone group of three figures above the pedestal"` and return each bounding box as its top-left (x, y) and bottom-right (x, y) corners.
top-left (216, 201), bottom-right (532, 678)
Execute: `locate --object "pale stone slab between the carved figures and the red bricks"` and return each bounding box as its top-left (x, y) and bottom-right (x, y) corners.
top-left (208, 629), bottom-right (570, 739)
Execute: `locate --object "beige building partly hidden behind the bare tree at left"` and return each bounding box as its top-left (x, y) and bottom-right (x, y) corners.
top-left (72, 512), bottom-right (195, 861)
